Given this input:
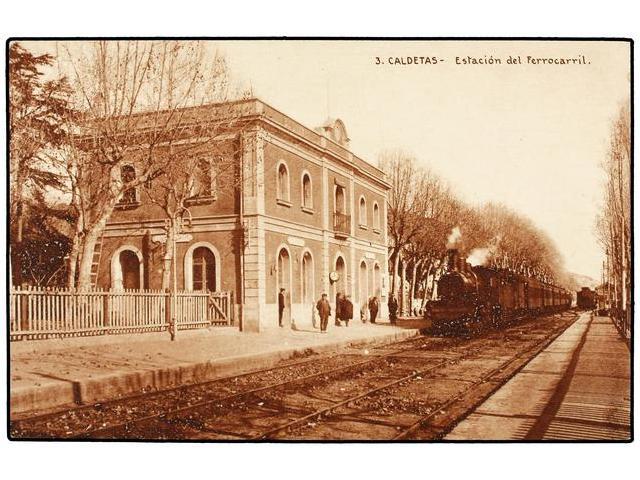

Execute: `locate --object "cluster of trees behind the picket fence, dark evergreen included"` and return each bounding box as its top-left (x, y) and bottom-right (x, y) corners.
top-left (9, 41), bottom-right (246, 288)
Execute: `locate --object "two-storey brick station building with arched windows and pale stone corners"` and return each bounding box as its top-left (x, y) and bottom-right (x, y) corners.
top-left (95, 99), bottom-right (390, 331)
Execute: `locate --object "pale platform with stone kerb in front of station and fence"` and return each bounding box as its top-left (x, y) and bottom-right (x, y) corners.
top-left (10, 319), bottom-right (424, 418)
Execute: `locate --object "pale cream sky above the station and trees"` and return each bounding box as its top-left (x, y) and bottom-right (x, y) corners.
top-left (22, 41), bottom-right (630, 279)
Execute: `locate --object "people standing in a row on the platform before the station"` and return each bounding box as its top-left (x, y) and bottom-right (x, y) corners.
top-left (278, 288), bottom-right (398, 333)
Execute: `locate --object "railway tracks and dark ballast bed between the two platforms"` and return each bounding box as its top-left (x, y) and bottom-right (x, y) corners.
top-left (11, 314), bottom-right (575, 440)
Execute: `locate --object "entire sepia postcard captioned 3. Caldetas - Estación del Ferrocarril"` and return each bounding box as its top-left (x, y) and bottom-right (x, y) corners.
top-left (6, 38), bottom-right (634, 443)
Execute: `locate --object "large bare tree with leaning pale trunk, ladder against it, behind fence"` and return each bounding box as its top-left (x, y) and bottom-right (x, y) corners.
top-left (60, 41), bottom-right (240, 288)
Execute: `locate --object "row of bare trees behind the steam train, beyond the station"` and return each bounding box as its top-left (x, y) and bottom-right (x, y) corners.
top-left (379, 150), bottom-right (566, 313)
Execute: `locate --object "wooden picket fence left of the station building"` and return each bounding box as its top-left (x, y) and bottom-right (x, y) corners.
top-left (9, 287), bottom-right (233, 340)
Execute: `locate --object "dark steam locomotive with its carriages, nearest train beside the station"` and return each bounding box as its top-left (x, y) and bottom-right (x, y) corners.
top-left (424, 249), bottom-right (571, 334)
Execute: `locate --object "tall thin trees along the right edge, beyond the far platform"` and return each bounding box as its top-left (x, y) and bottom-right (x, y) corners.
top-left (596, 105), bottom-right (632, 332)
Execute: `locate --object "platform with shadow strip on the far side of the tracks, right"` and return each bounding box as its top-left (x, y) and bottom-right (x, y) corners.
top-left (445, 313), bottom-right (632, 441)
